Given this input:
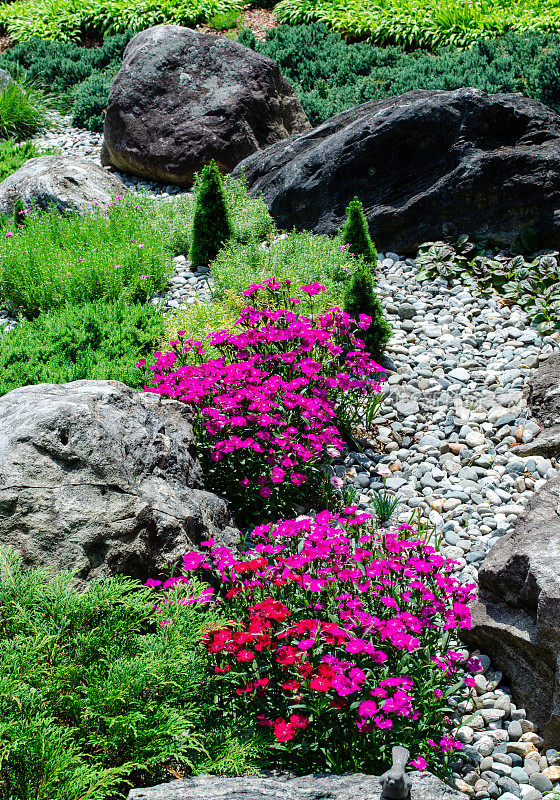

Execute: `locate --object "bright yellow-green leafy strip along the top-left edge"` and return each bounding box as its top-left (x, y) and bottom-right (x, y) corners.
top-left (0, 0), bottom-right (241, 42)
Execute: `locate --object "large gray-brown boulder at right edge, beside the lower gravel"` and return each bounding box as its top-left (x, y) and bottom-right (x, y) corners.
top-left (464, 478), bottom-right (560, 748)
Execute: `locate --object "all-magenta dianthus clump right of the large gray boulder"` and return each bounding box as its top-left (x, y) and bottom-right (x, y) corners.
top-left (139, 280), bottom-right (383, 524)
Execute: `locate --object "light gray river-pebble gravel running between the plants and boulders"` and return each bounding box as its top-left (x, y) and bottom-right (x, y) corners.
top-left (31, 115), bottom-right (560, 800)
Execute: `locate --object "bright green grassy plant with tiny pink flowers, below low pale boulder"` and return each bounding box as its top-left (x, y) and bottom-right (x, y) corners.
top-left (0, 192), bottom-right (177, 317)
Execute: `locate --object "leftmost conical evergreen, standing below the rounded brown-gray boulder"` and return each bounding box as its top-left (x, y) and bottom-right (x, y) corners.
top-left (190, 160), bottom-right (233, 267)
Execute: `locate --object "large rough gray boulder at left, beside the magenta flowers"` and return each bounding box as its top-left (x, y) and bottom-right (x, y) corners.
top-left (0, 381), bottom-right (236, 584)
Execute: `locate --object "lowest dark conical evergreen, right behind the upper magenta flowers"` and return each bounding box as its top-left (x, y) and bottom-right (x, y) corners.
top-left (344, 264), bottom-right (393, 361)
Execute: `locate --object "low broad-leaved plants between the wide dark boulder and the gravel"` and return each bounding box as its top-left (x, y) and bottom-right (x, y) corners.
top-left (416, 235), bottom-right (560, 336)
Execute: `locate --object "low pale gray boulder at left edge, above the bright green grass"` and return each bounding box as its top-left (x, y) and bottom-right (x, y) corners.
top-left (0, 155), bottom-right (126, 215)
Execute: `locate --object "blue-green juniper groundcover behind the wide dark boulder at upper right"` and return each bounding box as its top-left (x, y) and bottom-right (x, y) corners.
top-left (256, 23), bottom-right (560, 125)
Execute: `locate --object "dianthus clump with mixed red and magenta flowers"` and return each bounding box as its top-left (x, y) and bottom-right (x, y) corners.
top-left (164, 506), bottom-right (480, 774)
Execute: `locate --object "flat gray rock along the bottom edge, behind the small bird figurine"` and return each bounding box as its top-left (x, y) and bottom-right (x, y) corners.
top-left (127, 772), bottom-right (465, 800)
